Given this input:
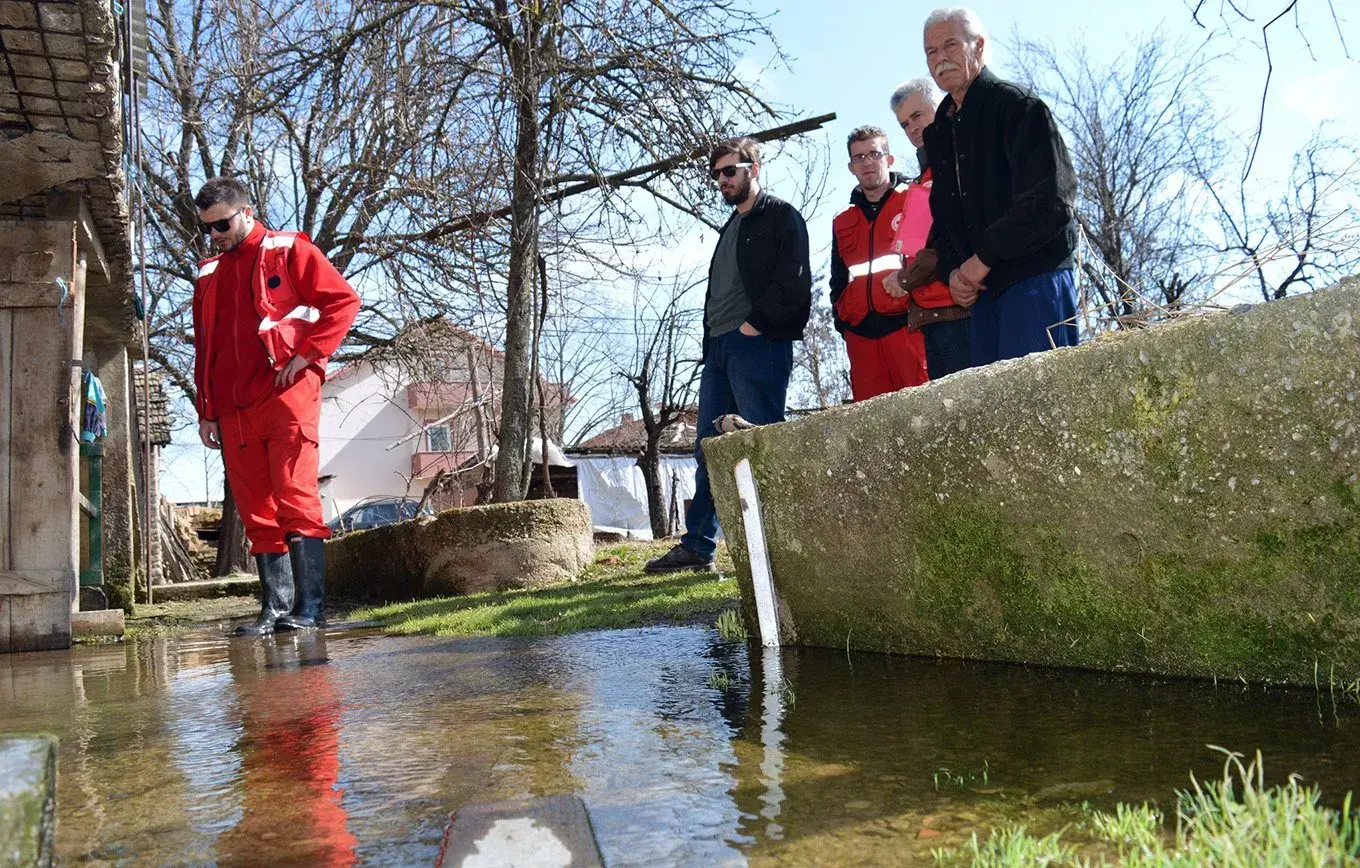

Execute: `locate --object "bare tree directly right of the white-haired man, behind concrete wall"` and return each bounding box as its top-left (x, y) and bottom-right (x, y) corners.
top-left (1016, 33), bottom-right (1223, 325)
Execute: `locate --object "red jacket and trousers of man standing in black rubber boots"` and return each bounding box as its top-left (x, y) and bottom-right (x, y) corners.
top-left (193, 223), bottom-right (359, 555)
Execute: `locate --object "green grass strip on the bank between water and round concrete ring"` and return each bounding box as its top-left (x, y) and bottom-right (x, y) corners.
top-left (350, 543), bottom-right (738, 635)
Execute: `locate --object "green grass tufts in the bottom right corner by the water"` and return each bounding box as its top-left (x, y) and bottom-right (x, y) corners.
top-left (934, 748), bottom-right (1360, 868)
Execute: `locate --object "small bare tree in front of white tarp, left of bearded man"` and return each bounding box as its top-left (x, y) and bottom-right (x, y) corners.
top-left (619, 283), bottom-right (703, 539)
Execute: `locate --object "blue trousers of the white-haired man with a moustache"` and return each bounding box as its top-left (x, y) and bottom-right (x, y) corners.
top-left (968, 268), bottom-right (1077, 367)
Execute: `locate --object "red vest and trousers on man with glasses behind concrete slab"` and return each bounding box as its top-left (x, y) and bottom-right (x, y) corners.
top-left (831, 185), bottom-right (929, 401)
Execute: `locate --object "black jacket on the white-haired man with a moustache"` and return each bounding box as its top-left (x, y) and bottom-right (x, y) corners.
top-left (925, 67), bottom-right (1077, 294)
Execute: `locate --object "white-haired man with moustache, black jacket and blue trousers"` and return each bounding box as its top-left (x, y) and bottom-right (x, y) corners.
top-left (925, 8), bottom-right (1077, 365)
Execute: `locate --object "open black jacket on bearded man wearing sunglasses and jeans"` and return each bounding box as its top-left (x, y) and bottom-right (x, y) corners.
top-left (703, 190), bottom-right (812, 347)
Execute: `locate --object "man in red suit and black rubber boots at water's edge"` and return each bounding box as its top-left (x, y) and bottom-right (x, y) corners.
top-left (193, 178), bottom-right (359, 635)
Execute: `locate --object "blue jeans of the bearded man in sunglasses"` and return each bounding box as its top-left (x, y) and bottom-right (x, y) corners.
top-left (680, 329), bottom-right (793, 558)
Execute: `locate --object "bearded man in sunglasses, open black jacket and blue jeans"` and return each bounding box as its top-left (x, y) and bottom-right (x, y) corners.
top-left (646, 139), bottom-right (812, 573)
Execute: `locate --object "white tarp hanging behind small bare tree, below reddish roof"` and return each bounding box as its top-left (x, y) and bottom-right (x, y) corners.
top-left (571, 456), bottom-right (696, 540)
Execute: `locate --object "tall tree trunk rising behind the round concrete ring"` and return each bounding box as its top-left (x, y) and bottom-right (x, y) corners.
top-left (491, 33), bottom-right (540, 503)
